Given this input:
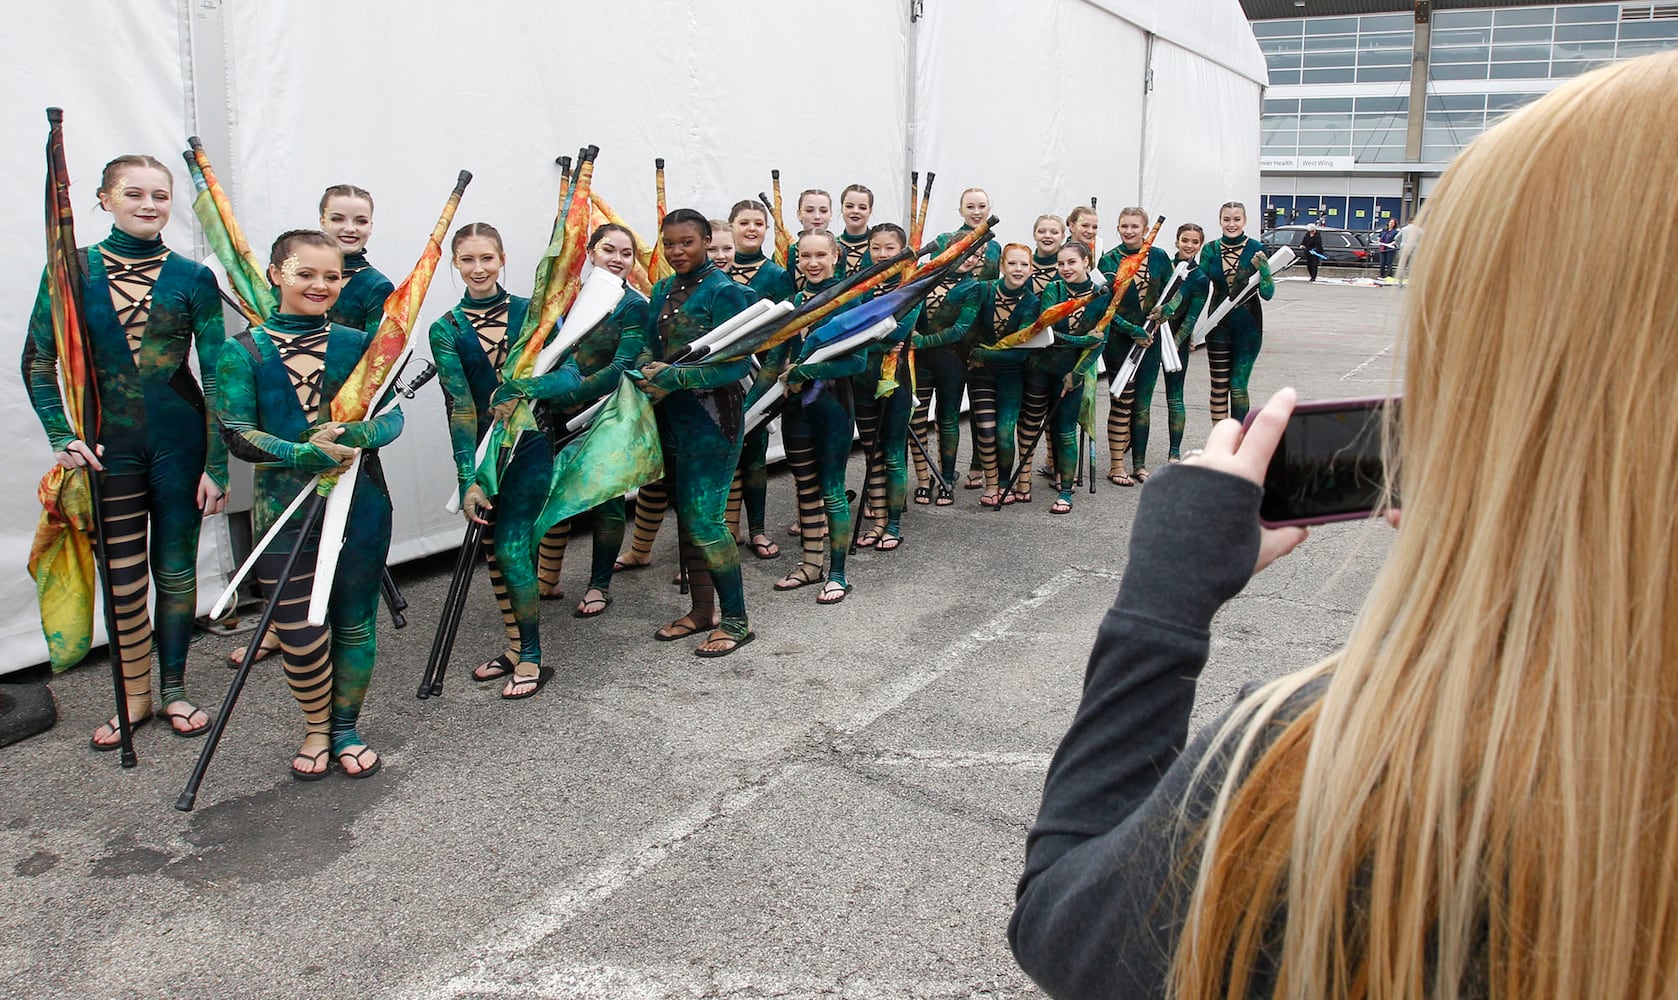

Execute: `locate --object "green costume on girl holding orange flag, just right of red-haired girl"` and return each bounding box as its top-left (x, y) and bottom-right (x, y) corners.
top-left (1025, 279), bottom-right (1113, 503)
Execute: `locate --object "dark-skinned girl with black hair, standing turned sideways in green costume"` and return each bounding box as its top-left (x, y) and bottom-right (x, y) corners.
top-left (636, 208), bottom-right (753, 656)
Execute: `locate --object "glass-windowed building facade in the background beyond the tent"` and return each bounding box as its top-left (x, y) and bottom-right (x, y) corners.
top-left (1252, 0), bottom-right (1678, 228)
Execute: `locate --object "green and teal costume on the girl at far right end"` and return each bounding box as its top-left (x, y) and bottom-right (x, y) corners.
top-left (1200, 237), bottom-right (1275, 421)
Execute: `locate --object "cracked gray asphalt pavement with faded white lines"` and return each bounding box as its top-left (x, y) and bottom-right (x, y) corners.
top-left (0, 272), bottom-right (1401, 1000)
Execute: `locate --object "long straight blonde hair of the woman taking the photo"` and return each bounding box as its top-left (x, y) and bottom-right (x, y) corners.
top-left (1173, 52), bottom-right (1678, 1000)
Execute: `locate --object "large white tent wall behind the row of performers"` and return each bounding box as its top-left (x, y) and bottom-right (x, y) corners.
top-left (0, 0), bottom-right (1265, 673)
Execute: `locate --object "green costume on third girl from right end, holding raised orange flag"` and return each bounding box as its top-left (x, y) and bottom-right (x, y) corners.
top-left (1096, 243), bottom-right (1171, 477)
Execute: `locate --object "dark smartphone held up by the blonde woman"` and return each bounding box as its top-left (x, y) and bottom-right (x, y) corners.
top-left (1247, 398), bottom-right (1401, 527)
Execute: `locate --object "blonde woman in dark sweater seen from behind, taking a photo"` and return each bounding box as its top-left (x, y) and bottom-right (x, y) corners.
top-left (1010, 52), bottom-right (1678, 1000)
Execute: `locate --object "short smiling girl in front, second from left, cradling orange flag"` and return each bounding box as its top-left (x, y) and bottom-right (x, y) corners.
top-left (216, 230), bottom-right (403, 782)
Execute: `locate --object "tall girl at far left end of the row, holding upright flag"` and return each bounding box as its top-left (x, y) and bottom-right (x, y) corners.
top-left (23, 156), bottom-right (227, 750)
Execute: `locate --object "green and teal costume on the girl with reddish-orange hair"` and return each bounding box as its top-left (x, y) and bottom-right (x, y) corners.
top-left (967, 279), bottom-right (1040, 497)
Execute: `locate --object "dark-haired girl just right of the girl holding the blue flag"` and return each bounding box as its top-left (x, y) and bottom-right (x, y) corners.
top-left (852, 221), bottom-right (921, 552)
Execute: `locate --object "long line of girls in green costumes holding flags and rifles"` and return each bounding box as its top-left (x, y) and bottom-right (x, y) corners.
top-left (23, 138), bottom-right (1274, 780)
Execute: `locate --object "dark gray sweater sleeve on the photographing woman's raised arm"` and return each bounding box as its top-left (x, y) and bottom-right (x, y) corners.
top-left (1008, 465), bottom-right (1260, 998)
